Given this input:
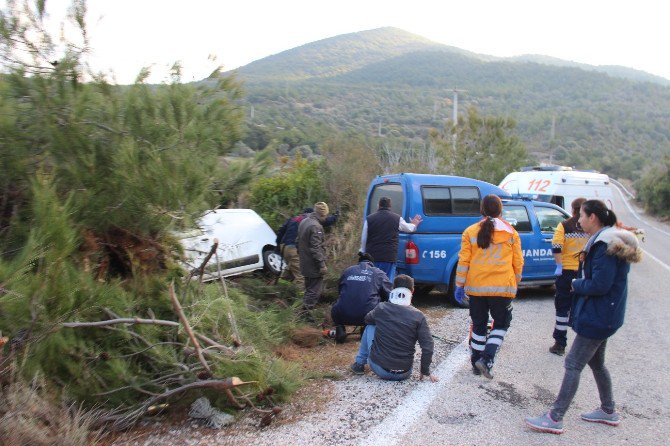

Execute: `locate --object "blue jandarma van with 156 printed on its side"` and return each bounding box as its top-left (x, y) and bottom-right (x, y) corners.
top-left (365, 173), bottom-right (569, 300)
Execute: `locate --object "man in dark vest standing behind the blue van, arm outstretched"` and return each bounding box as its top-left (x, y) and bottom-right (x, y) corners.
top-left (361, 197), bottom-right (421, 281)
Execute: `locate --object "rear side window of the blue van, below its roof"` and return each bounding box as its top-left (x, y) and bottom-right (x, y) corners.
top-left (421, 186), bottom-right (480, 215)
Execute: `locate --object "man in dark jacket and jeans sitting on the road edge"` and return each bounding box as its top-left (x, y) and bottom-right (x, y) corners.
top-left (351, 274), bottom-right (437, 382)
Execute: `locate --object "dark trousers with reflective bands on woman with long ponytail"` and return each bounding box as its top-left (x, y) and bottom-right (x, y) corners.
top-left (470, 296), bottom-right (512, 365)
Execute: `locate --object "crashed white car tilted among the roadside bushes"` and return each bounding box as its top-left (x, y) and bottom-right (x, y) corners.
top-left (177, 209), bottom-right (284, 280)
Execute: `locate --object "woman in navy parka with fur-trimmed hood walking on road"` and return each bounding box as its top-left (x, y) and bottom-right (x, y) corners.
top-left (526, 200), bottom-right (642, 434)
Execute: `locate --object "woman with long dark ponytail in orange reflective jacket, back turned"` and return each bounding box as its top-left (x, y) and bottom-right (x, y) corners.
top-left (454, 195), bottom-right (523, 379)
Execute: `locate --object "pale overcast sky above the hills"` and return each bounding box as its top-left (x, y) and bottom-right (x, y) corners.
top-left (47, 0), bottom-right (670, 84)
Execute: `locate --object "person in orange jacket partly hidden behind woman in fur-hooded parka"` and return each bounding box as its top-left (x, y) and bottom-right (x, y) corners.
top-left (549, 198), bottom-right (589, 356)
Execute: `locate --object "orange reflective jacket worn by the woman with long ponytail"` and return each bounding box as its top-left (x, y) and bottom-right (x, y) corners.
top-left (456, 222), bottom-right (523, 298)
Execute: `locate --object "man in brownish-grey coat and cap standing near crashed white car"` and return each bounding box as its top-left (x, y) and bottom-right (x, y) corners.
top-left (296, 201), bottom-right (328, 310)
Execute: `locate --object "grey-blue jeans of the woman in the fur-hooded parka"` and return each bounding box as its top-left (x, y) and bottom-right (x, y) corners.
top-left (551, 335), bottom-right (614, 421)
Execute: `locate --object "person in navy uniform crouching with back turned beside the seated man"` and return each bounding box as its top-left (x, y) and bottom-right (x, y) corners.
top-left (330, 253), bottom-right (392, 342)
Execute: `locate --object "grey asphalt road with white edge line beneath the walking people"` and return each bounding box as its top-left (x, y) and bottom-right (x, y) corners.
top-left (372, 186), bottom-right (670, 446)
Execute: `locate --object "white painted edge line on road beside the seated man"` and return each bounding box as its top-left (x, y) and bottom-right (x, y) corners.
top-left (360, 337), bottom-right (470, 446)
